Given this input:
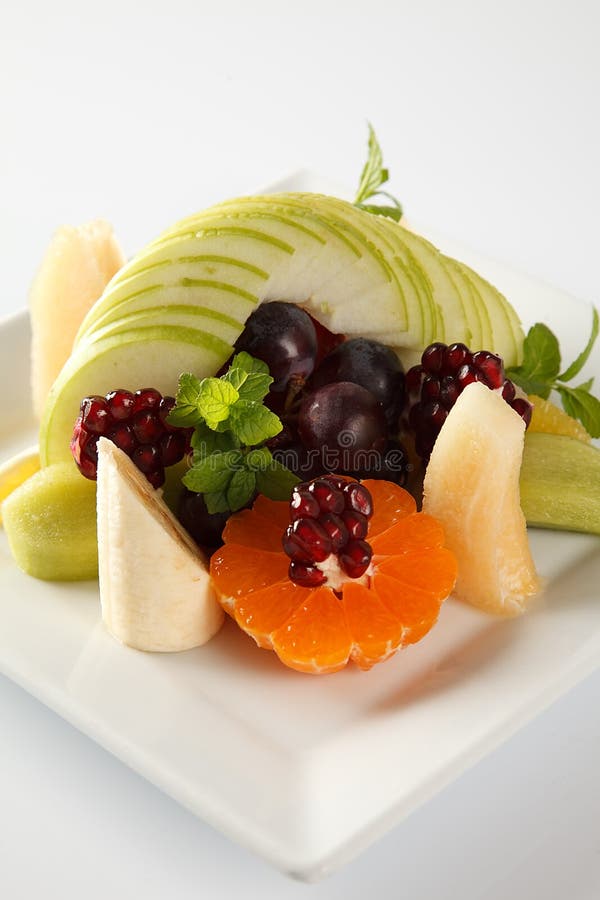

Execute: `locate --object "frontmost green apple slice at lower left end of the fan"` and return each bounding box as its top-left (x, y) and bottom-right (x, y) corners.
top-left (40, 325), bottom-right (232, 466)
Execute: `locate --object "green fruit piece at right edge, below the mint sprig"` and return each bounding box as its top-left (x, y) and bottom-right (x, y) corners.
top-left (520, 431), bottom-right (600, 534)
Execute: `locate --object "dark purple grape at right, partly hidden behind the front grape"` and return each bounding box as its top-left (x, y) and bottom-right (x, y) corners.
top-left (311, 338), bottom-right (404, 418)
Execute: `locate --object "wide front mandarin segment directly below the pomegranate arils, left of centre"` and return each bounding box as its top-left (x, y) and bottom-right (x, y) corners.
top-left (272, 587), bottom-right (352, 675)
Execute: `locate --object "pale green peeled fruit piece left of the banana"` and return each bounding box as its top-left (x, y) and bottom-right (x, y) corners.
top-left (2, 460), bottom-right (98, 581)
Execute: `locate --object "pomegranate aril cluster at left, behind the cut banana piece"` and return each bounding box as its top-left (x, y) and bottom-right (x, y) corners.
top-left (71, 388), bottom-right (193, 487)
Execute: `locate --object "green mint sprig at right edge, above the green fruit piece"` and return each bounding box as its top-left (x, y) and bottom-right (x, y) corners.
top-left (506, 308), bottom-right (600, 438)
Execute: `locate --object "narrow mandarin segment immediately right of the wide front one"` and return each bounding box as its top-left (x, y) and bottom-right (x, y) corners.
top-left (342, 581), bottom-right (403, 669)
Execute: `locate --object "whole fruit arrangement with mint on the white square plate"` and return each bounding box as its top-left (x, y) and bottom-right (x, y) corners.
top-left (0, 131), bottom-right (600, 674)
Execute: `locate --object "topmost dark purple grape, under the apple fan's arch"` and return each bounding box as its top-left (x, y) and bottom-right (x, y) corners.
top-left (235, 300), bottom-right (317, 392)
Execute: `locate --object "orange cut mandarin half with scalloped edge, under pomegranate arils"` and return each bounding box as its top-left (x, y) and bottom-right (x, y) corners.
top-left (210, 480), bottom-right (457, 674)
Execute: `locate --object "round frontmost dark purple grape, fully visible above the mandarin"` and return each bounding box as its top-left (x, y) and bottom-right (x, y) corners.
top-left (298, 381), bottom-right (387, 472)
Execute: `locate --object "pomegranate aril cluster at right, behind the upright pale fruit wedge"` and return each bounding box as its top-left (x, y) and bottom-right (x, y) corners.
top-left (406, 342), bottom-right (532, 462)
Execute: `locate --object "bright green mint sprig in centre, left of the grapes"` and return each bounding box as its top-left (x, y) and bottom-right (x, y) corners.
top-left (167, 353), bottom-right (298, 513)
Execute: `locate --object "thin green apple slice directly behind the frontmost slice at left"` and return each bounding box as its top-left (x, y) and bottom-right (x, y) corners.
top-left (78, 304), bottom-right (240, 349)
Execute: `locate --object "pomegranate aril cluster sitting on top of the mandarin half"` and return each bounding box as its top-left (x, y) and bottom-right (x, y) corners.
top-left (283, 475), bottom-right (373, 587)
